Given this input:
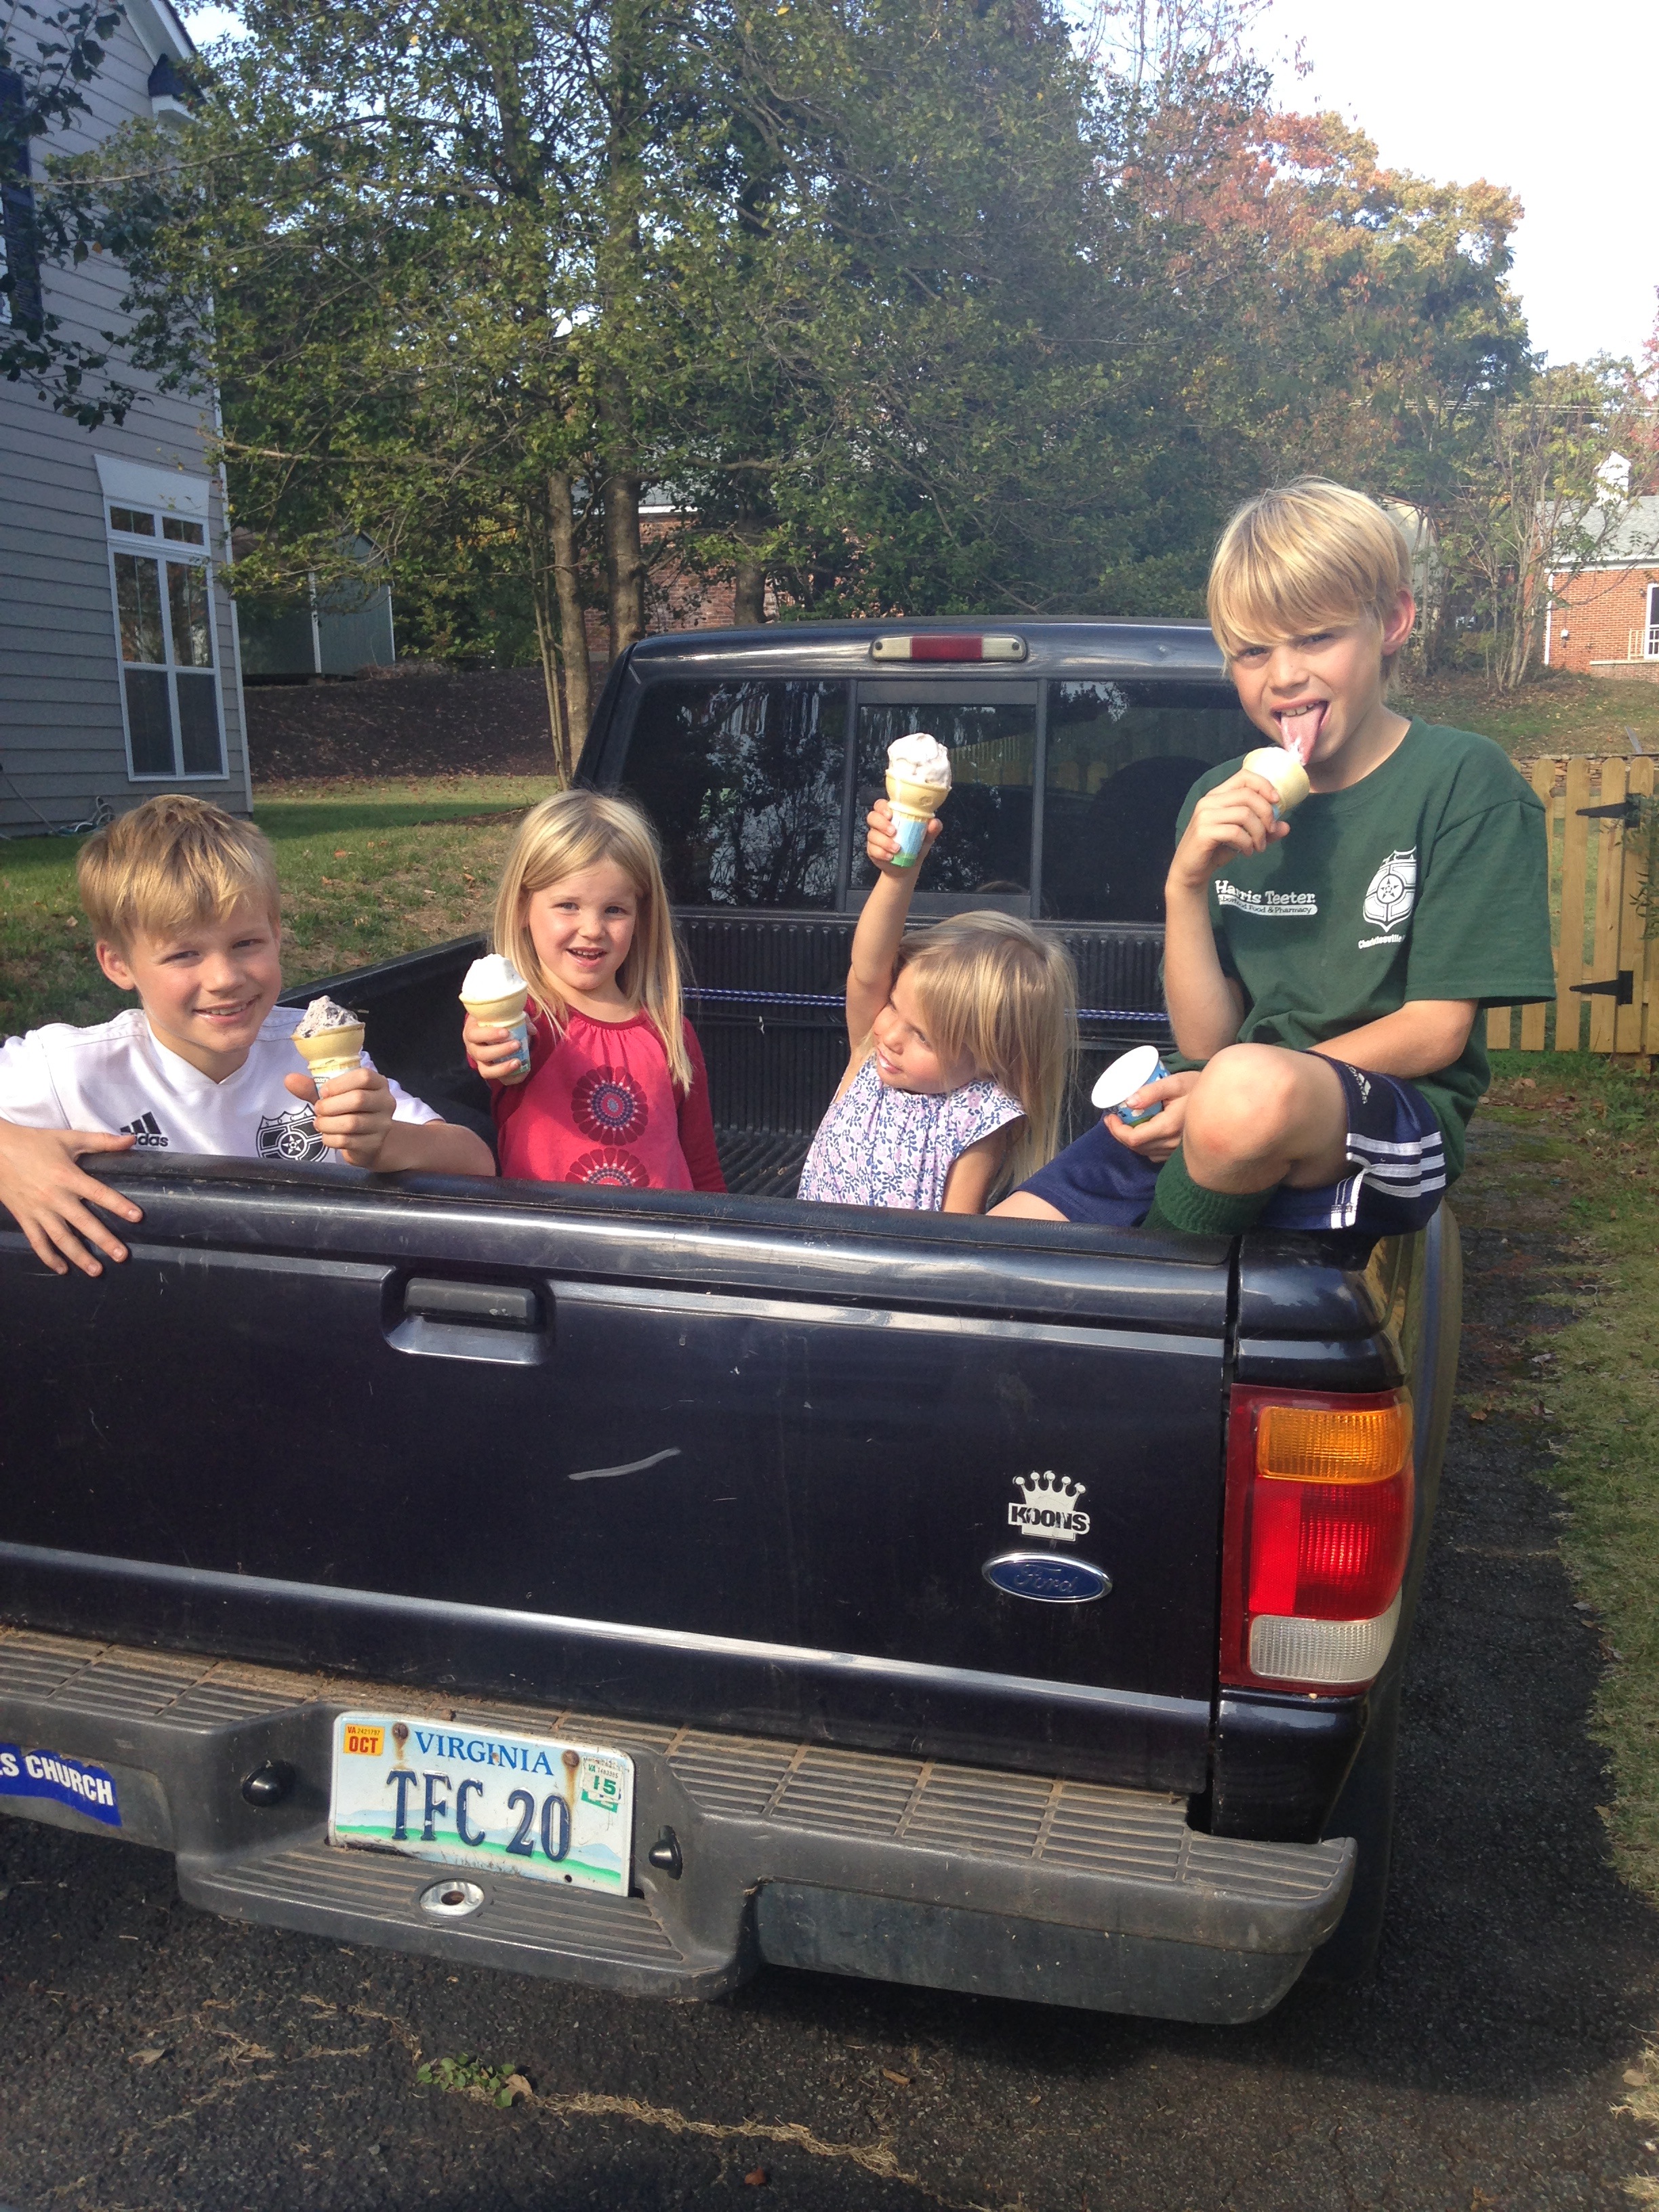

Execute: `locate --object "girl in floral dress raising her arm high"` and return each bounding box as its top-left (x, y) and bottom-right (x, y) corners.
top-left (801, 798), bottom-right (1078, 1214)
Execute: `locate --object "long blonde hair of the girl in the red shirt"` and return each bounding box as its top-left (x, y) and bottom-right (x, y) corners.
top-left (491, 792), bottom-right (693, 1092)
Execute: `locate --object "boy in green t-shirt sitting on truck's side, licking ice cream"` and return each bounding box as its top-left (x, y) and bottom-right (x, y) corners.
top-left (994, 478), bottom-right (1555, 1237)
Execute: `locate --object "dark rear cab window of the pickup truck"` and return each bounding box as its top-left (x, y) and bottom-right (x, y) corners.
top-left (606, 623), bottom-right (1252, 929)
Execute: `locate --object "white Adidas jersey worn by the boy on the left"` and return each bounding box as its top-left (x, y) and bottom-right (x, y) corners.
top-left (0, 1006), bottom-right (443, 1168)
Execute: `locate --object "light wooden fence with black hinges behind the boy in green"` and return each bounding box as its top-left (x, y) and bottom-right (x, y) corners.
top-left (1486, 754), bottom-right (1659, 1053)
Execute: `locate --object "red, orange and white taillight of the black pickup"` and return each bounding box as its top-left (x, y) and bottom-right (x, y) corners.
top-left (1221, 1389), bottom-right (1414, 1694)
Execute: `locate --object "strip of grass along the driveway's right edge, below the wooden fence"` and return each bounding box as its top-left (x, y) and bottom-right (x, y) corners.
top-left (1453, 1053), bottom-right (1659, 1902)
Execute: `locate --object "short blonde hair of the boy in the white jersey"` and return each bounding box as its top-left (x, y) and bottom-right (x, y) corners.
top-left (75, 792), bottom-right (281, 954)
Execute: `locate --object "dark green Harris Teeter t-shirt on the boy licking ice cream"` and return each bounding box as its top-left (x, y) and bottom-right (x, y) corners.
top-left (1179, 721), bottom-right (1555, 1179)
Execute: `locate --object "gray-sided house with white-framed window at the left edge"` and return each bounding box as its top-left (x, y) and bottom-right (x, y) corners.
top-left (0, 0), bottom-right (252, 836)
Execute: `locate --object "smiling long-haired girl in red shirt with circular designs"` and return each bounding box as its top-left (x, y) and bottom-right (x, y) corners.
top-left (462, 792), bottom-right (726, 1190)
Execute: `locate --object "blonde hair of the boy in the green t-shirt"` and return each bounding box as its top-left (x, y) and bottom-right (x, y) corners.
top-left (1210, 476), bottom-right (1411, 665)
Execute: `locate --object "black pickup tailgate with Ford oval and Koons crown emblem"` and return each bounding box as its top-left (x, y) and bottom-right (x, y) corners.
top-left (0, 1159), bottom-right (1228, 1792)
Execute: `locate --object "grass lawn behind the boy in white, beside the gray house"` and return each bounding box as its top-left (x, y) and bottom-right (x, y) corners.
top-left (0, 777), bottom-right (548, 1036)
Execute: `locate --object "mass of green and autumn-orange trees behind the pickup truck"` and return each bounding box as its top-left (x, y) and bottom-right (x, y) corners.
top-left (29, 0), bottom-right (1574, 743)
